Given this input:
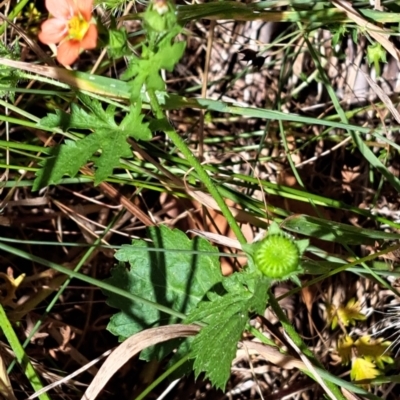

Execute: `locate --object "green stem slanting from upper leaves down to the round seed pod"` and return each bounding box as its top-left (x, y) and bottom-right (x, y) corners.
top-left (147, 89), bottom-right (247, 244)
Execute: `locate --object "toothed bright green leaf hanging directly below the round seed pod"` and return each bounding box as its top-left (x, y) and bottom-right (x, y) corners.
top-left (185, 270), bottom-right (271, 389)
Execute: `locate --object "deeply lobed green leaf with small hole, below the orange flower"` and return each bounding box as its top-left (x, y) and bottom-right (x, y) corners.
top-left (33, 95), bottom-right (151, 190)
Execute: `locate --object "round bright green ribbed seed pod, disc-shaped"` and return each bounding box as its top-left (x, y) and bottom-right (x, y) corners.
top-left (254, 234), bottom-right (300, 279)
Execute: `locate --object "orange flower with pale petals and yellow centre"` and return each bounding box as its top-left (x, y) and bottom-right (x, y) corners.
top-left (39, 0), bottom-right (97, 65)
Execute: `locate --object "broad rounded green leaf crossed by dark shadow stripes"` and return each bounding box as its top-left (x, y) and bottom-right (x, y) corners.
top-left (106, 226), bottom-right (223, 358)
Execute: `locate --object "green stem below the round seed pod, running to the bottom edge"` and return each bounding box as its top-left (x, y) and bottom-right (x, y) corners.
top-left (268, 289), bottom-right (345, 400)
